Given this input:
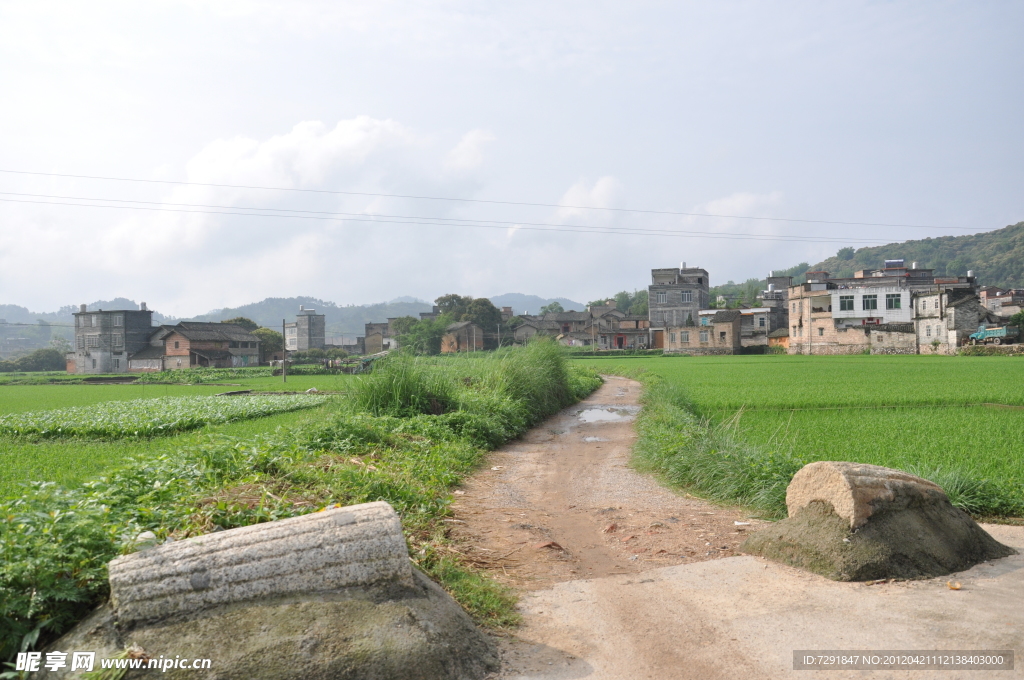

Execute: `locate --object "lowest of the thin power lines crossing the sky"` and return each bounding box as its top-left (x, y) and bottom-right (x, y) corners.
top-left (0, 198), bottom-right (897, 244)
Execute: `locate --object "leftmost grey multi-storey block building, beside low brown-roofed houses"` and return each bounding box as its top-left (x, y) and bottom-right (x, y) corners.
top-left (66, 302), bottom-right (154, 374)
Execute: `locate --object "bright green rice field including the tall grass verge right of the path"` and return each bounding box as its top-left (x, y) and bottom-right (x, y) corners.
top-left (581, 355), bottom-right (1024, 516)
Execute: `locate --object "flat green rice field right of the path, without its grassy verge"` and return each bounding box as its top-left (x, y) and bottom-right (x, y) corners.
top-left (581, 355), bottom-right (1024, 514)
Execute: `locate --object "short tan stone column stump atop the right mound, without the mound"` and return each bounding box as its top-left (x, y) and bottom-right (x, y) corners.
top-left (785, 461), bottom-right (946, 528)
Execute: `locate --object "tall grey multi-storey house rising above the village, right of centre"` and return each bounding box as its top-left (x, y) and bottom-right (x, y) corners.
top-left (647, 262), bottom-right (711, 348)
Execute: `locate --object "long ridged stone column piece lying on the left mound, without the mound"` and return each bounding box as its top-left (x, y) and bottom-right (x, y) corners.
top-left (109, 502), bottom-right (413, 624)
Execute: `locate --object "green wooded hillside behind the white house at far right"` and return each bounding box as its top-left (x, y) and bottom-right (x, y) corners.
top-left (812, 222), bottom-right (1024, 288)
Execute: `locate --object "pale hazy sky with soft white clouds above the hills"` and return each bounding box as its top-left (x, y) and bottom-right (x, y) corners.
top-left (0, 0), bottom-right (1024, 316)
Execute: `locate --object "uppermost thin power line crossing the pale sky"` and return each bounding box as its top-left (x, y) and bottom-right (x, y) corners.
top-left (0, 169), bottom-right (964, 229)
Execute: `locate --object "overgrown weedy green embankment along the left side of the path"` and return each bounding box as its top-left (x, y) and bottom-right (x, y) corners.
top-left (0, 343), bottom-right (600, 658)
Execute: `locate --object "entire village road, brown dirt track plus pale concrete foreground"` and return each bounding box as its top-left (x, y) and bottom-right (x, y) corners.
top-left (452, 378), bottom-right (1024, 680)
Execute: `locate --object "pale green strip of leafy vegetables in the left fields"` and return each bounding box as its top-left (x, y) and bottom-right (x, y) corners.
top-left (0, 394), bottom-right (327, 438)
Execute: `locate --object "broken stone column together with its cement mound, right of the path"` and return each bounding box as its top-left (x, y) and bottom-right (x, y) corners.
top-left (740, 462), bottom-right (1016, 581)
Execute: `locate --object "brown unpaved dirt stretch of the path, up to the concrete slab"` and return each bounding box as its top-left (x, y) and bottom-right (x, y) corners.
top-left (451, 377), bottom-right (758, 589)
